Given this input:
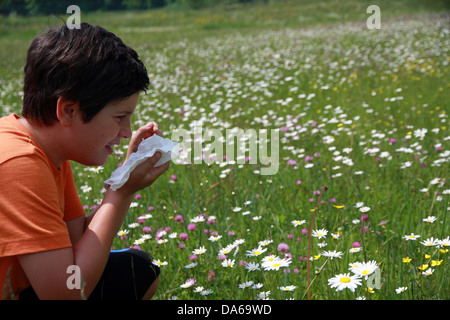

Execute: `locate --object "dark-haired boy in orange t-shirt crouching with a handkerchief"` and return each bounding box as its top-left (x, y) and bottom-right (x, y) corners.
top-left (0, 23), bottom-right (169, 299)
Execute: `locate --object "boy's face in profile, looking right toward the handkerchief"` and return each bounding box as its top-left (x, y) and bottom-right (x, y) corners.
top-left (70, 93), bottom-right (139, 166)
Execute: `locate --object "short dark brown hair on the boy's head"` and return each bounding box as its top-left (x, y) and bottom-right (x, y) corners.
top-left (22, 23), bottom-right (149, 125)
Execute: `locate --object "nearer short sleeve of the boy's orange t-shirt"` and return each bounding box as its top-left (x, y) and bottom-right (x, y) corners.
top-left (0, 154), bottom-right (72, 257)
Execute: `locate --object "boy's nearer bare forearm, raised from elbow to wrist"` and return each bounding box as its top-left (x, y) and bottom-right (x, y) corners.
top-left (73, 190), bottom-right (133, 295)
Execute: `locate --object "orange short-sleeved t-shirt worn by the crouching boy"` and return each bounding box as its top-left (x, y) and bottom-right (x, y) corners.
top-left (0, 114), bottom-right (84, 299)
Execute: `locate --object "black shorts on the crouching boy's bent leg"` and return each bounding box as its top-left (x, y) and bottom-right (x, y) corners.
top-left (19, 249), bottom-right (159, 300)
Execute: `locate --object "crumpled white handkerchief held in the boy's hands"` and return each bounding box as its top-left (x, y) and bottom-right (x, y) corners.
top-left (105, 135), bottom-right (179, 191)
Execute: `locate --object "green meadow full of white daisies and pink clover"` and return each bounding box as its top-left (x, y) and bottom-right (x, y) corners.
top-left (0, 0), bottom-right (450, 300)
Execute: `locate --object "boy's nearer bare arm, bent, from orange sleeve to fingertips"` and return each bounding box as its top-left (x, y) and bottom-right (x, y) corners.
top-left (18, 122), bottom-right (169, 299)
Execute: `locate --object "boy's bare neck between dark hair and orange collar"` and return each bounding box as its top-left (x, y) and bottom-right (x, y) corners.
top-left (19, 118), bottom-right (67, 168)
